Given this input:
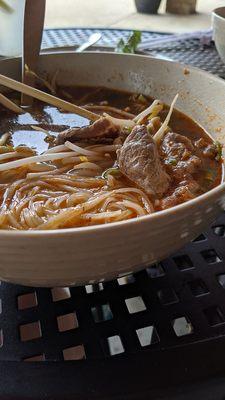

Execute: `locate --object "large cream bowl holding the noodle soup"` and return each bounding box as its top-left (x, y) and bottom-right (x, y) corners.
top-left (0, 53), bottom-right (225, 286)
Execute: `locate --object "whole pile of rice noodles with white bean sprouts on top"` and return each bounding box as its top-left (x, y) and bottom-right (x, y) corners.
top-left (0, 120), bottom-right (153, 230)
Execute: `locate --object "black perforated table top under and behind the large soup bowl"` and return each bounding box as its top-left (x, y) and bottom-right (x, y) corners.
top-left (0, 29), bottom-right (225, 400)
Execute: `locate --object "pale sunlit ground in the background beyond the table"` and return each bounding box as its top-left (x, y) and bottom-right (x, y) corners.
top-left (46, 0), bottom-right (225, 32)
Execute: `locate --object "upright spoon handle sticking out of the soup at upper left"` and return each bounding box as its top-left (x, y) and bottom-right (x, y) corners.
top-left (21, 0), bottom-right (46, 106)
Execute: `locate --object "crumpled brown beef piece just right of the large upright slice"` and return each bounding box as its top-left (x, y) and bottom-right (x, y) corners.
top-left (161, 132), bottom-right (202, 181)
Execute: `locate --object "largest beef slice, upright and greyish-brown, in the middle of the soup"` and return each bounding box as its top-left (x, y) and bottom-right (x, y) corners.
top-left (118, 125), bottom-right (170, 197)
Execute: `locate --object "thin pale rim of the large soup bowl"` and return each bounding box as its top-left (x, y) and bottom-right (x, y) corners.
top-left (0, 50), bottom-right (225, 238)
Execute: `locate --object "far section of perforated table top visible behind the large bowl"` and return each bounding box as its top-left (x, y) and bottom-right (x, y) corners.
top-left (42, 28), bottom-right (225, 78)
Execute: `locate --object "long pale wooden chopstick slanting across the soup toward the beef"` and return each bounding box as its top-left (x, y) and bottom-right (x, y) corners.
top-left (0, 74), bottom-right (100, 121)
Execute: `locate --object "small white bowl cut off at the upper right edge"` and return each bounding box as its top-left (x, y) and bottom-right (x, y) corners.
top-left (212, 7), bottom-right (225, 62)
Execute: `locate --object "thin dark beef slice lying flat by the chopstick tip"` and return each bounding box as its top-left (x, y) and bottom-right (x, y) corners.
top-left (56, 117), bottom-right (118, 144)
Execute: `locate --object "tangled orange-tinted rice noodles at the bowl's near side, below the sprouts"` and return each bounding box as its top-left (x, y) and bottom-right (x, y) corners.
top-left (1, 167), bottom-right (151, 229)
